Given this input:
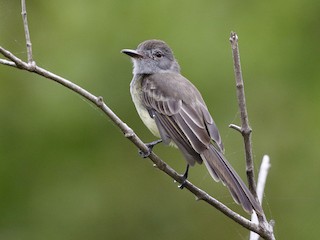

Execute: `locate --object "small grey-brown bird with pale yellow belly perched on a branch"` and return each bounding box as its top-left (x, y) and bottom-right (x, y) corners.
top-left (121, 39), bottom-right (262, 213)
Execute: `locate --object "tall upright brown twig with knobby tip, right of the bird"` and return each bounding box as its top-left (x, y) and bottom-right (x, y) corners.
top-left (230, 32), bottom-right (257, 198)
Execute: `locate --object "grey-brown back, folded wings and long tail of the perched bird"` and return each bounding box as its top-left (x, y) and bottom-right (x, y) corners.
top-left (141, 73), bottom-right (262, 213)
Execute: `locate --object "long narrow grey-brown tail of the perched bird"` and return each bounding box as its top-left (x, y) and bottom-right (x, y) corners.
top-left (201, 145), bottom-right (262, 213)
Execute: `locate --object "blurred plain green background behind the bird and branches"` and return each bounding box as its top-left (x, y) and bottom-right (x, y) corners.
top-left (0, 0), bottom-right (320, 240)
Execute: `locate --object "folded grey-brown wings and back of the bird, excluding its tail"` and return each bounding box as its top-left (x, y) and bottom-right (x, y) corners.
top-left (141, 73), bottom-right (223, 165)
